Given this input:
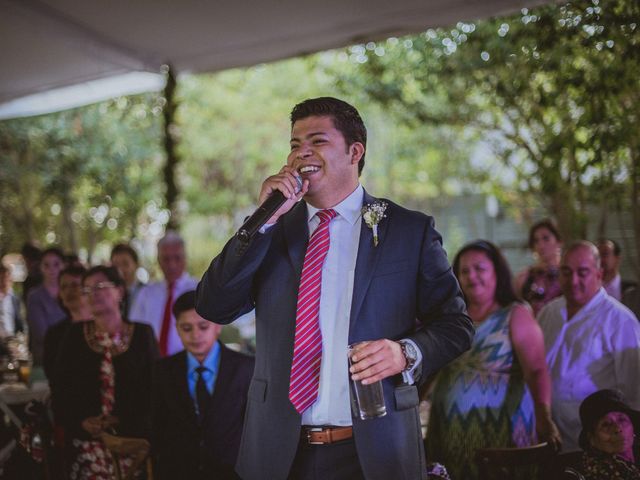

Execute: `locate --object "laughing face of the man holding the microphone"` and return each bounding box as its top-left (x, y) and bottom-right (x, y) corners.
top-left (287, 116), bottom-right (364, 208)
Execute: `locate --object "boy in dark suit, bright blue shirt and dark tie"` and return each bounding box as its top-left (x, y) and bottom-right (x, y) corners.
top-left (152, 290), bottom-right (254, 480)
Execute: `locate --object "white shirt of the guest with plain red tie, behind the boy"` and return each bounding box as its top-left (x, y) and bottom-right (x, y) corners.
top-left (129, 272), bottom-right (198, 355)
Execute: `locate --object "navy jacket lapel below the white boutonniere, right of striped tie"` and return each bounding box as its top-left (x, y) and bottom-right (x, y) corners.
top-left (349, 191), bottom-right (389, 341)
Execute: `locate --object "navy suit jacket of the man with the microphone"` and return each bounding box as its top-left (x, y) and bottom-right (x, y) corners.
top-left (196, 192), bottom-right (473, 480)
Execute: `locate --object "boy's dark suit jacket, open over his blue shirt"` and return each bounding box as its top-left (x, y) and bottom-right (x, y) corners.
top-left (152, 343), bottom-right (254, 480)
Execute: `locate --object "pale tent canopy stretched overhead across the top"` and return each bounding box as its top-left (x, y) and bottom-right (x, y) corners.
top-left (0, 0), bottom-right (544, 118)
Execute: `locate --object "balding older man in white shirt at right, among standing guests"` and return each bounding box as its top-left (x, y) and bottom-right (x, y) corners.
top-left (538, 241), bottom-right (640, 451)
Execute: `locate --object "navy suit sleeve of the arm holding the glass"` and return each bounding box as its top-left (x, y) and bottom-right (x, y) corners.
top-left (409, 217), bottom-right (474, 382)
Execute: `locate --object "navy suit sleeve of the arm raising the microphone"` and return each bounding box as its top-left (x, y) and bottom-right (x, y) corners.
top-left (196, 225), bottom-right (278, 324)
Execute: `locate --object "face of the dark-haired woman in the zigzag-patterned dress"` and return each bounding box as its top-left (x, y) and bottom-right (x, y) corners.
top-left (458, 250), bottom-right (497, 305)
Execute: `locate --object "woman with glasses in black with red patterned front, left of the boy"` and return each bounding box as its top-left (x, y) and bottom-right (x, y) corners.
top-left (54, 266), bottom-right (159, 479)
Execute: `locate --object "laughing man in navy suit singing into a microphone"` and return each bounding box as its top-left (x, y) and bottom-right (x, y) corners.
top-left (196, 97), bottom-right (473, 480)
